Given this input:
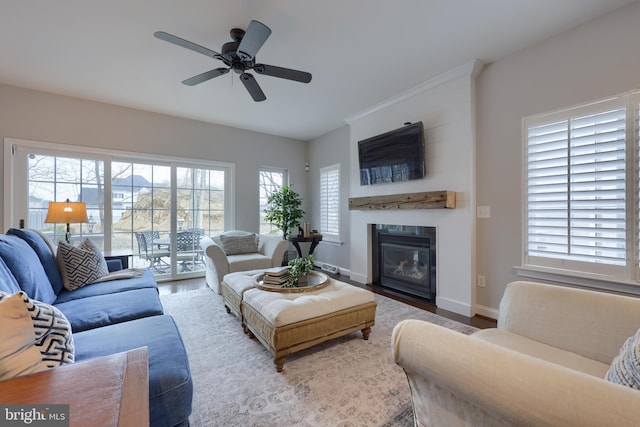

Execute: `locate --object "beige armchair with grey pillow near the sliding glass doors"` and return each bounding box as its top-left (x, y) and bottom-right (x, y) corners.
top-left (200, 230), bottom-right (289, 293)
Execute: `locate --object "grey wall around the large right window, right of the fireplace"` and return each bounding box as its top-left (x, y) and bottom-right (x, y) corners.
top-left (476, 2), bottom-right (640, 313)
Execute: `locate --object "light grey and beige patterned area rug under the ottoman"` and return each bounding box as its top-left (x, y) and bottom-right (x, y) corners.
top-left (161, 288), bottom-right (476, 427)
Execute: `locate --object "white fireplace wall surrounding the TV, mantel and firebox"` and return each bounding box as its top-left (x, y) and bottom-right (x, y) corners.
top-left (347, 61), bottom-right (481, 316)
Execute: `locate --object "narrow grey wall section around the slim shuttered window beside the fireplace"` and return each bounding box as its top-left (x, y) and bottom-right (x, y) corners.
top-left (307, 125), bottom-right (350, 274)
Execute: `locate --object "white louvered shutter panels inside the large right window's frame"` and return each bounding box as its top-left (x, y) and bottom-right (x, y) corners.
top-left (526, 107), bottom-right (627, 266)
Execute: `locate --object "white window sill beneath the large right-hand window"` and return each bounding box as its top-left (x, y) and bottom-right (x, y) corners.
top-left (513, 266), bottom-right (640, 296)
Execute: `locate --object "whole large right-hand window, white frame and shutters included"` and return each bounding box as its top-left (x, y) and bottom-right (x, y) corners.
top-left (524, 94), bottom-right (640, 282)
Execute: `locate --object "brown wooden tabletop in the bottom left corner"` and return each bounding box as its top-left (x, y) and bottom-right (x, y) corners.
top-left (0, 347), bottom-right (149, 427)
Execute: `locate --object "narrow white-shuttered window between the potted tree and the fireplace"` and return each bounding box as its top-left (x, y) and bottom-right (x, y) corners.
top-left (320, 165), bottom-right (340, 241)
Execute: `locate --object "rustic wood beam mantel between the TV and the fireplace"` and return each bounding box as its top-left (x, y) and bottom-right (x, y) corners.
top-left (349, 190), bottom-right (456, 210)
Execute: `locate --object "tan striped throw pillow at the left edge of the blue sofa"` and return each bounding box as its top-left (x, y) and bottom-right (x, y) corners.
top-left (0, 292), bottom-right (48, 380)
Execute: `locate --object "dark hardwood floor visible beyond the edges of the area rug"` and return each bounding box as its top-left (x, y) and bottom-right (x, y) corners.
top-left (158, 274), bottom-right (496, 329)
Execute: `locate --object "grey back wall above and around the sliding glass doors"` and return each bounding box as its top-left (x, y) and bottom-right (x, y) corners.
top-left (0, 85), bottom-right (310, 232)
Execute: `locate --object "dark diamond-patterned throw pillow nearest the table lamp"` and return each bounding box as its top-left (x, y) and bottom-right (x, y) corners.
top-left (56, 239), bottom-right (109, 291)
